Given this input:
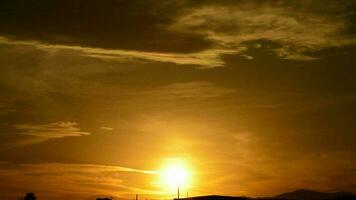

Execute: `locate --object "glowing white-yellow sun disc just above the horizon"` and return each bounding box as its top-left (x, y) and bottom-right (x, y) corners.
top-left (161, 160), bottom-right (191, 190)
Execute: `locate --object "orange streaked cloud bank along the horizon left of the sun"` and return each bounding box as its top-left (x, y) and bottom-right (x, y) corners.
top-left (0, 163), bottom-right (157, 199)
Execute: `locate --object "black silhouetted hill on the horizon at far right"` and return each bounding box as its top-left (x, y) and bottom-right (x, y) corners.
top-left (275, 189), bottom-right (356, 200)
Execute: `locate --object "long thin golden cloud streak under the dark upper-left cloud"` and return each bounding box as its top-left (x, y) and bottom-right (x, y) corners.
top-left (0, 37), bottom-right (241, 68)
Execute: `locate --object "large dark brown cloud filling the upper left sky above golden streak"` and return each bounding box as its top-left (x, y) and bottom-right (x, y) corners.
top-left (0, 0), bottom-right (210, 52)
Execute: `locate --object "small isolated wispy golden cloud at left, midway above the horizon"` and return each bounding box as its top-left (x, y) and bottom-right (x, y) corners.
top-left (14, 121), bottom-right (90, 141)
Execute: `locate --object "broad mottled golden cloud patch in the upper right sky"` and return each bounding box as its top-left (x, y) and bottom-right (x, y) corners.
top-left (169, 1), bottom-right (356, 60)
